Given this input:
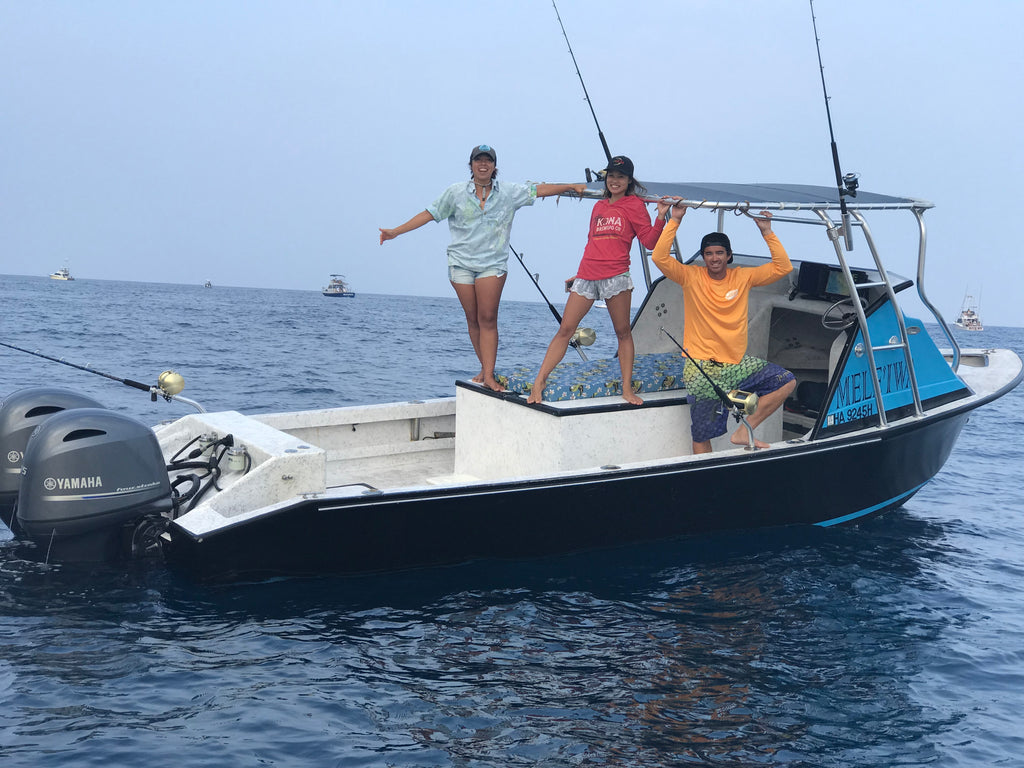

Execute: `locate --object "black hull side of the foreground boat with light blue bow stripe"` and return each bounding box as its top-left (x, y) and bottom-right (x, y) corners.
top-left (165, 409), bottom-right (970, 577)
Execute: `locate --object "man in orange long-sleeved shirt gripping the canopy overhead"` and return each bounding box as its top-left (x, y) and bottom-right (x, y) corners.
top-left (653, 205), bottom-right (797, 454)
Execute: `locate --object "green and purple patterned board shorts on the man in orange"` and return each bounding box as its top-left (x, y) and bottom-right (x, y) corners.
top-left (683, 354), bottom-right (796, 442)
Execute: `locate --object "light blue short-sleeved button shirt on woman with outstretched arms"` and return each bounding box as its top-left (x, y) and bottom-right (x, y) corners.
top-left (427, 179), bottom-right (537, 272)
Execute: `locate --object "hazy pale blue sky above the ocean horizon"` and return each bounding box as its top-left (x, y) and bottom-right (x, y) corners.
top-left (0, 0), bottom-right (1024, 326)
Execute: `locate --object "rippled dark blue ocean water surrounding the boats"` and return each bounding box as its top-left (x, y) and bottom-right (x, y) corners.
top-left (0, 276), bottom-right (1024, 768)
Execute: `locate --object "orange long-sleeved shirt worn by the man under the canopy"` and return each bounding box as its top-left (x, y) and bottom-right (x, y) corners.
top-left (652, 221), bottom-right (793, 364)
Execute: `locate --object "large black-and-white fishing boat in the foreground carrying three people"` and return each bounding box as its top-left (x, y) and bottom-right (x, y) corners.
top-left (0, 183), bottom-right (1024, 579)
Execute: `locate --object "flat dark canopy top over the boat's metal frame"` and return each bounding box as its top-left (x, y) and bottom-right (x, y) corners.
top-left (587, 181), bottom-right (932, 211)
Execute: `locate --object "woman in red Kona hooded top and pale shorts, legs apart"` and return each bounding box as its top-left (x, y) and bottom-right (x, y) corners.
top-left (527, 156), bottom-right (670, 406)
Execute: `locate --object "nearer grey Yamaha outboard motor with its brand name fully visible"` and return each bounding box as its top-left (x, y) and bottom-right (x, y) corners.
top-left (17, 408), bottom-right (174, 561)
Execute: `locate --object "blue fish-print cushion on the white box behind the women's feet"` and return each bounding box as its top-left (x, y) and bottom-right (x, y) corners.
top-left (497, 352), bottom-right (686, 402)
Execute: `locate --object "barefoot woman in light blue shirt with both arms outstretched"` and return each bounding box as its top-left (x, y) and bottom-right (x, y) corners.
top-left (381, 144), bottom-right (587, 392)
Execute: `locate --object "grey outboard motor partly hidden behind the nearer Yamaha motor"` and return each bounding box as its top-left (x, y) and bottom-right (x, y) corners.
top-left (0, 387), bottom-right (102, 525)
